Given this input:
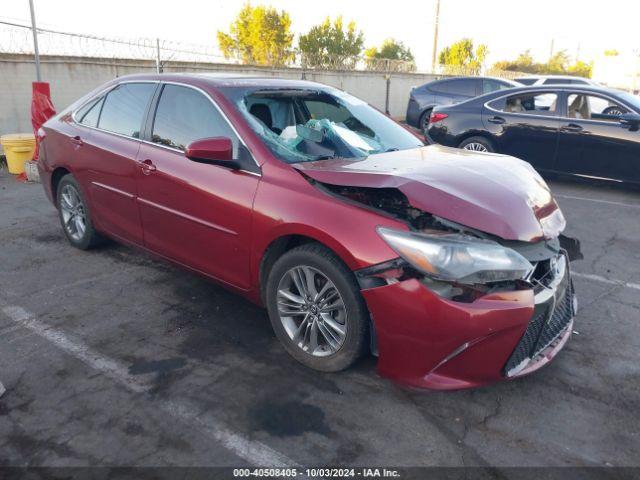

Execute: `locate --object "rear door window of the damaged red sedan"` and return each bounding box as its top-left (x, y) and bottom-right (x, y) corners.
top-left (98, 83), bottom-right (156, 138)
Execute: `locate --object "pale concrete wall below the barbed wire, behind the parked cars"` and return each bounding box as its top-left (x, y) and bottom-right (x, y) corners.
top-left (0, 54), bottom-right (435, 144)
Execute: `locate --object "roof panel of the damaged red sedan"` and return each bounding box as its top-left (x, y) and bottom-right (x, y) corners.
top-left (109, 72), bottom-right (326, 88)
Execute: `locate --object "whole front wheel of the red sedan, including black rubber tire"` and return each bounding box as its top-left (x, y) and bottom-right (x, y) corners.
top-left (265, 243), bottom-right (369, 372)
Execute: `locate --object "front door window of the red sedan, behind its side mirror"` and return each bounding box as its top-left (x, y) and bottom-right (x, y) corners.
top-left (152, 85), bottom-right (238, 154)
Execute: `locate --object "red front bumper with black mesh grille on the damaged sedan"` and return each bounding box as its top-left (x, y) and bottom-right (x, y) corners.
top-left (362, 255), bottom-right (576, 390)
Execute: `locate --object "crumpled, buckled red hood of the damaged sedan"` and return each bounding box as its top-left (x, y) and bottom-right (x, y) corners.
top-left (293, 145), bottom-right (565, 242)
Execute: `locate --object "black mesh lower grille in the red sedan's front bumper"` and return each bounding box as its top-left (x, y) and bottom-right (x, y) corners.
top-left (504, 262), bottom-right (574, 376)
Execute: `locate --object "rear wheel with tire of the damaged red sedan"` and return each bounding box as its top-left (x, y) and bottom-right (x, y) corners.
top-left (56, 174), bottom-right (104, 250)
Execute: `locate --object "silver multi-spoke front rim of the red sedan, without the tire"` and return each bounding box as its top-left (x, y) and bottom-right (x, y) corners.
top-left (277, 266), bottom-right (347, 357)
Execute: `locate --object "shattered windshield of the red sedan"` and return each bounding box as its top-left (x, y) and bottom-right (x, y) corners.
top-left (228, 87), bottom-right (423, 163)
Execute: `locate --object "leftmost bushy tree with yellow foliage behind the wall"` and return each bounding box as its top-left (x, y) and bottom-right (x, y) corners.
top-left (218, 3), bottom-right (293, 66)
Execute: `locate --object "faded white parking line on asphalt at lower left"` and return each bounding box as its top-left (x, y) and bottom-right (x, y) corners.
top-left (0, 299), bottom-right (299, 467)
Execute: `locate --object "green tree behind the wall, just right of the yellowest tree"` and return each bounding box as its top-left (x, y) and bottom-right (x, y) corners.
top-left (298, 16), bottom-right (364, 69)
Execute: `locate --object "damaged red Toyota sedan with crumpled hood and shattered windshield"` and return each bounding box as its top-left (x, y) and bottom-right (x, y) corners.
top-left (39, 74), bottom-right (576, 389)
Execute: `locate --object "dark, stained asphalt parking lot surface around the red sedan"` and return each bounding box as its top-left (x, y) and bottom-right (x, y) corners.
top-left (0, 172), bottom-right (640, 467)
